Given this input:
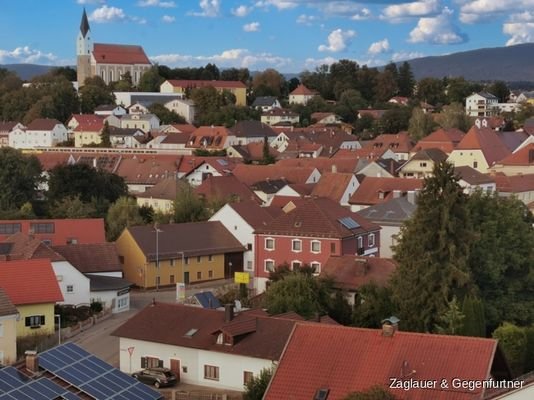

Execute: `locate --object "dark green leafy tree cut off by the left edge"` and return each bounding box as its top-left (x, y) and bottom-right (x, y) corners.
top-left (0, 147), bottom-right (42, 211)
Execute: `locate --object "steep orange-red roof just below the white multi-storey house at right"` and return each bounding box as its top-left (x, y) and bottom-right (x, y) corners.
top-left (456, 125), bottom-right (510, 166)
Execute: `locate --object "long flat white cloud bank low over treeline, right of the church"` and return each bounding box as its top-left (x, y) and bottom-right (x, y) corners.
top-left (150, 49), bottom-right (291, 68)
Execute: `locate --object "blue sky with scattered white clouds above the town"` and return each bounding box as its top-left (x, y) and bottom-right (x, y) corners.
top-left (0, 0), bottom-right (534, 73)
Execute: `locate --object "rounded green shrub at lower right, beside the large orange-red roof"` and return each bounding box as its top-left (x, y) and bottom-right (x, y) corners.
top-left (492, 322), bottom-right (527, 377)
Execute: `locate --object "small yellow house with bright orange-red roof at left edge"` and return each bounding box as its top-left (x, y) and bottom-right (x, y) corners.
top-left (0, 259), bottom-right (63, 337)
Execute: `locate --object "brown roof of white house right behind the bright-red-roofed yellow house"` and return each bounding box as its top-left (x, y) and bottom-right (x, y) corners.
top-left (52, 243), bottom-right (122, 274)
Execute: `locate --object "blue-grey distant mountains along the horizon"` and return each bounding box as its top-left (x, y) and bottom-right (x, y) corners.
top-left (0, 43), bottom-right (534, 82)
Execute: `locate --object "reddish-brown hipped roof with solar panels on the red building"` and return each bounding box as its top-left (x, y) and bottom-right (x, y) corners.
top-left (256, 198), bottom-right (380, 238)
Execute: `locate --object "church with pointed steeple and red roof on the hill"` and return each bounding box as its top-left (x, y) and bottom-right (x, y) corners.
top-left (76, 9), bottom-right (152, 87)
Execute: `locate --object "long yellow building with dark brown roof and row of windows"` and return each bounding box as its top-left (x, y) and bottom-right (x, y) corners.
top-left (115, 221), bottom-right (245, 288)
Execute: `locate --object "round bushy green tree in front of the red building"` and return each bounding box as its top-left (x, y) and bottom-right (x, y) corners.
top-left (264, 272), bottom-right (333, 319)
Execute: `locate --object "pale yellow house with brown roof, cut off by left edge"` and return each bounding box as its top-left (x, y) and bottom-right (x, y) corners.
top-left (0, 288), bottom-right (19, 365)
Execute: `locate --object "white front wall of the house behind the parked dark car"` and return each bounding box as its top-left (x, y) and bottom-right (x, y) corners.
top-left (119, 338), bottom-right (273, 391)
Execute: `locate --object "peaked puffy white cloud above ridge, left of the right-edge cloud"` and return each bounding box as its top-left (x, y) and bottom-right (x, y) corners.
top-left (408, 7), bottom-right (467, 44)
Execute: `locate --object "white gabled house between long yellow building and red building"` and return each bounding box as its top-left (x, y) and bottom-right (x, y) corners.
top-left (210, 201), bottom-right (273, 282)
